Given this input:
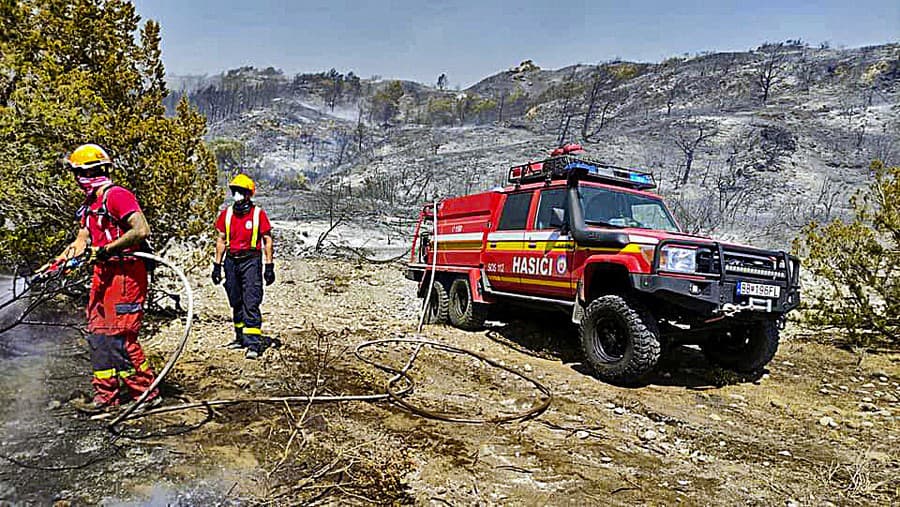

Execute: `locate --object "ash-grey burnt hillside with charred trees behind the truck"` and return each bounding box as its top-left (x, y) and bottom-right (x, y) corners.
top-left (170, 41), bottom-right (900, 245)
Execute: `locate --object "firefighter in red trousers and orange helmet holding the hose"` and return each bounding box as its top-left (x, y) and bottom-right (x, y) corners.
top-left (49, 144), bottom-right (160, 409)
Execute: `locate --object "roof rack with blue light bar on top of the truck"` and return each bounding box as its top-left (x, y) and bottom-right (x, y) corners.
top-left (509, 156), bottom-right (656, 190)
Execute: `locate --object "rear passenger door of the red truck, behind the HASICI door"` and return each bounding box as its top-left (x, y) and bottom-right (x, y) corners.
top-left (484, 191), bottom-right (534, 292)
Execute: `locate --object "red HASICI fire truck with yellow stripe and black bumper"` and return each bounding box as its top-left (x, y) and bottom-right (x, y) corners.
top-left (407, 145), bottom-right (800, 383)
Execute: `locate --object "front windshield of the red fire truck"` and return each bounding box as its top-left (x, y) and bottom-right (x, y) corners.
top-left (579, 185), bottom-right (681, 232)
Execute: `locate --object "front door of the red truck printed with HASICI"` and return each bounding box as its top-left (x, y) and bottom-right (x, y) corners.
top-left (515, 187), bottom-right (575, 300)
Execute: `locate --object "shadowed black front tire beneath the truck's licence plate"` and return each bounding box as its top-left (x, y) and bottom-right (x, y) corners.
top-left (700, 320), bottom-right (779, 373)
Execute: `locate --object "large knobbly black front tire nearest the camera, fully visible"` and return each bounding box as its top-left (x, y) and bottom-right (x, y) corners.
top-left (578, 296), bottom-right (661, 385)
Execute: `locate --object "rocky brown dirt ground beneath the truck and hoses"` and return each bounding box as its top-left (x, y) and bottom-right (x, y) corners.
top-left (0, 258), bottom-right (900, 505)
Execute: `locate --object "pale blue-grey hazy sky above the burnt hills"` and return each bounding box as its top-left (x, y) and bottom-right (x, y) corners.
top-left (135, 0), bottom-right (900, 88)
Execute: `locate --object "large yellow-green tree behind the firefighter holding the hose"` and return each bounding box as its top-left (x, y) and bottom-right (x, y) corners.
top-left (0, 0), bottom-right (222, 264)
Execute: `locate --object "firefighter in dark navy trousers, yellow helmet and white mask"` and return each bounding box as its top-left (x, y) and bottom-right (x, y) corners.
top-left (212, 174), bottom-right (275, 359)
